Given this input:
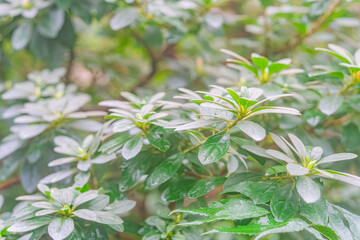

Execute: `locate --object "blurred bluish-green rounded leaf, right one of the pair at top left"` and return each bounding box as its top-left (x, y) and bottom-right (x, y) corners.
top-left (36, 8), bottom-right (65, 38)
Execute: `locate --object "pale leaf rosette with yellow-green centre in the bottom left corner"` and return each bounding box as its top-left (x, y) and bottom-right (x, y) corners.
top-left (2, 184), bottom-right (135, 240)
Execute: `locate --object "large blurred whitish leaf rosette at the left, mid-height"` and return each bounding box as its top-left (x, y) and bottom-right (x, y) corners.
top-left (10, 94), bottom-right (104, 139)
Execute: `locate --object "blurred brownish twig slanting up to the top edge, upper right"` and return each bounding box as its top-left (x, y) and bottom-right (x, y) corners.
top-left (275, 0), bottom-right (340, 54)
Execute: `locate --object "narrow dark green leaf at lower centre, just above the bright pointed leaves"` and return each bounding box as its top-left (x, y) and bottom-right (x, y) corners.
top-left (188, 177), bottom-right (226, 198)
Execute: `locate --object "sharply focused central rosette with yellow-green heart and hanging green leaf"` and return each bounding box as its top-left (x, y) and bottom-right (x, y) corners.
top-left (174, 86), bottom-right (300, 164)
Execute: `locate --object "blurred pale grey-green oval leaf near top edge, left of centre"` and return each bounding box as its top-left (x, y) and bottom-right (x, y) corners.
top-left (110, 8), bottom-right (138, 31)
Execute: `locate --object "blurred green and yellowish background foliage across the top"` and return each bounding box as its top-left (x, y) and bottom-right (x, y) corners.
top-left (0, 0), bottom-right (359, 99)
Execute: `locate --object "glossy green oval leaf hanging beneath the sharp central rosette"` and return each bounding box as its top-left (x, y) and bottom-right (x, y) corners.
top-left (198, 132), bottom-right (230, 165)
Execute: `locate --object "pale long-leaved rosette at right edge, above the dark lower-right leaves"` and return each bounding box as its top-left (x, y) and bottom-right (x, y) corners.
top-left (242, 133), bottom-right (360, 203)
